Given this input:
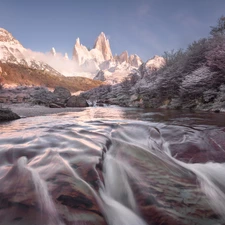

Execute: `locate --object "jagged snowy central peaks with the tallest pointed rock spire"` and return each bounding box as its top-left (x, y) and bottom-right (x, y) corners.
top-left (73, 32), bottom-right (142, 84)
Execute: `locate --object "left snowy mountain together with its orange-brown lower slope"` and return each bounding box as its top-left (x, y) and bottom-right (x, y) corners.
top-left (0, 28), bottom-right (101, 92)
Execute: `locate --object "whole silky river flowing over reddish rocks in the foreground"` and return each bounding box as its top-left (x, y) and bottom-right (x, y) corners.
top-left (0, 107), bottom-right (225, 225)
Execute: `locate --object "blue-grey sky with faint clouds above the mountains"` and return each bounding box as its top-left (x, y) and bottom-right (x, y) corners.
top-left (0, 0), bottom-right (225, 61)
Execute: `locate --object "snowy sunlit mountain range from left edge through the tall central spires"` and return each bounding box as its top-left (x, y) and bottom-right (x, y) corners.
top-left (0, 28), bottom-right (163, 84)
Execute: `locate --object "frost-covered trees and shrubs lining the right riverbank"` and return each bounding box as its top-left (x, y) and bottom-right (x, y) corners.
top-left (81, 16), bottom-right (225, 110)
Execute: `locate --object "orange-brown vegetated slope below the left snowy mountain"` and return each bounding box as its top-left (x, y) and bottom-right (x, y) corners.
top-left (0, 62), bottom-right (102, 92)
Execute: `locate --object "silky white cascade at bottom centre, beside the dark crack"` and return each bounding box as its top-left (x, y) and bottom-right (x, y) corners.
top-left (100, 152), bottom-right (146, 225)
